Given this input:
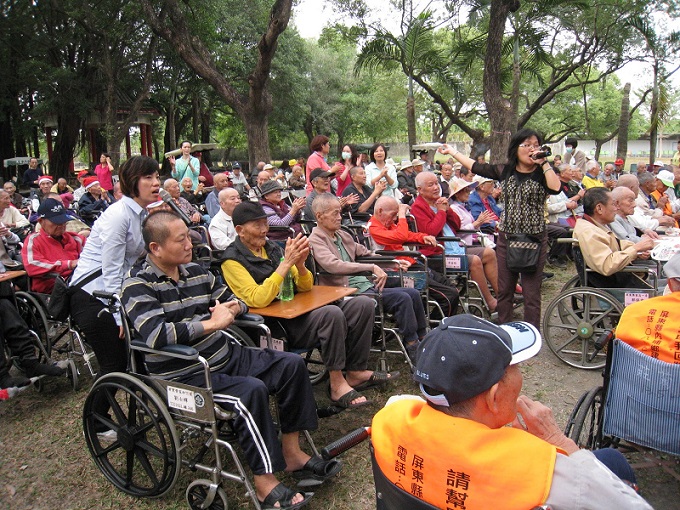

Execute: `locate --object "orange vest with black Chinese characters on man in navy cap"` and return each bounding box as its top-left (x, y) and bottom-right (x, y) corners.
top-left (371, 400), bottom-right (558, 510)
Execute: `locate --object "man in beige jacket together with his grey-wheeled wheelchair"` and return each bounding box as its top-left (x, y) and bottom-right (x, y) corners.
top-left (542, 187), bottom-right (660, 369)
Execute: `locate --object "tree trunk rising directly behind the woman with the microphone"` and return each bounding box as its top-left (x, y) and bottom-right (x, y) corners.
top-left (483, 0), bottom-right (519, 164)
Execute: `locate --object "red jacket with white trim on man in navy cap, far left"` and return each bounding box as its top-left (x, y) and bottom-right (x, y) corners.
top-left (21, 230), bottom-right (85, 294)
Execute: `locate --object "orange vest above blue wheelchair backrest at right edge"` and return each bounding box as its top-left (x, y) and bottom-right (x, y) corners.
top-left (616, 292), bottom-right (680, 364)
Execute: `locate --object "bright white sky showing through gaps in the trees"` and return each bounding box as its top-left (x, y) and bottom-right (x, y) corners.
top-left (293, 0), bottom-right (680, 91)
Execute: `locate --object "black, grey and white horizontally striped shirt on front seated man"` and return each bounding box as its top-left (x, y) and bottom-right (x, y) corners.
top-left (122, 256), bottom-right (247, 378)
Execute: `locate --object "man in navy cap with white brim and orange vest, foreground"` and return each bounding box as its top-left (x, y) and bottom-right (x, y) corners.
top-left (371, 315), bottom-right (651, 510)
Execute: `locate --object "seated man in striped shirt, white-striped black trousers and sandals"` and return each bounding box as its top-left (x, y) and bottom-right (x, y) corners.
top-left (122, 212), bottom-right (341, 509)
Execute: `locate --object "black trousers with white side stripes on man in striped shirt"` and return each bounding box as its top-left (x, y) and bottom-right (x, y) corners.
top-left (180, 344), bottom-right (318, 475)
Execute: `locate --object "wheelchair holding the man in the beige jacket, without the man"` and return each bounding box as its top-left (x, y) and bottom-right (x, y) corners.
top-left (542, 240), bottom-right (661, 370)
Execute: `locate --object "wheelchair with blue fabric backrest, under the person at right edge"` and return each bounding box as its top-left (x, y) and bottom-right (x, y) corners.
top-left (564, 330), bottom-right (680, 481)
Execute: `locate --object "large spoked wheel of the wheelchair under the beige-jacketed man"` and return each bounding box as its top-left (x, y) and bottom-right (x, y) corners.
top-left (543, 287), bottom-right (623, 369)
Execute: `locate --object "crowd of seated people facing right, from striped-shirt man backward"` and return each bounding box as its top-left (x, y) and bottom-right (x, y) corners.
top-left (0, 144), bottom-right (680, 508)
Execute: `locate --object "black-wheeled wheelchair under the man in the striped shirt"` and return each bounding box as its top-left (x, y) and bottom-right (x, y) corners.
top-left (82, 291), bottom-right (326, 510)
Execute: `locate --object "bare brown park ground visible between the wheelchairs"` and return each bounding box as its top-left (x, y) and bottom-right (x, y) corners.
top-left (0, 265), bottom-right (680, 510)
